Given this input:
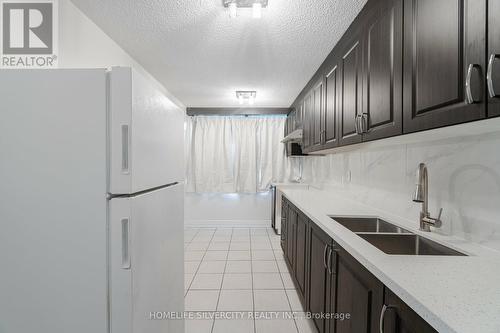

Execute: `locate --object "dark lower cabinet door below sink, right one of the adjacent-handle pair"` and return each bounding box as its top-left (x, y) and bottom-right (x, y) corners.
top-left (336, 248), bottom-right (384, 333)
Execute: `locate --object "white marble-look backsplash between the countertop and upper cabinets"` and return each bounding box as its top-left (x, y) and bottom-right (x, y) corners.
top-left (294, 132), bottom-right (500, 250)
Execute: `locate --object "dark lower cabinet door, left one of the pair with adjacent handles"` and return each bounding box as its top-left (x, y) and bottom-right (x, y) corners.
top-left (306, 223), bottom-right (332, 333)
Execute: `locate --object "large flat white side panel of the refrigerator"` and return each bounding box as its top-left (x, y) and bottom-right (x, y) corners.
top-left (0, 69), bottom-right (108, 333)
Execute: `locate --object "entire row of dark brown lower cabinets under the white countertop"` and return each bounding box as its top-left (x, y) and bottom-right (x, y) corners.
top-left (281, 198), bottom-right (436, 333)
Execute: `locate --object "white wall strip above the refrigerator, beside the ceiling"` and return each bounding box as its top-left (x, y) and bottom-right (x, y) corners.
top-left (59, 0), bottom-right (184, 108)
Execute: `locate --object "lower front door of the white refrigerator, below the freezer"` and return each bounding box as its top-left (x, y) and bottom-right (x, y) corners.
top-left (110, 184), bottom-right (184, 333)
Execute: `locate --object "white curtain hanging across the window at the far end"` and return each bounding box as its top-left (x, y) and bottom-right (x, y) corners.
top-left (185, 116), bottom-right (292, 193)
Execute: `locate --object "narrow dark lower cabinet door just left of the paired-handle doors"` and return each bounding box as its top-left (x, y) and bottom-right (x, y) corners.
top-left (294, 213), bottom-right (309, 298)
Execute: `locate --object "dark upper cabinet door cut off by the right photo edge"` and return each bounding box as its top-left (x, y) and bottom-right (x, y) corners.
top-left (487, 0), bottom-right (500, 117)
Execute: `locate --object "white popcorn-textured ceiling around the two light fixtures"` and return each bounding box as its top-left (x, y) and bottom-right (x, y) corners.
top-left (72, 0), bottom-right (366, 107)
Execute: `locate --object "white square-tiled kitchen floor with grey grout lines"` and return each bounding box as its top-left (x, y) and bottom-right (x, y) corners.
top-left (184, 227), bottom-right (315, 333)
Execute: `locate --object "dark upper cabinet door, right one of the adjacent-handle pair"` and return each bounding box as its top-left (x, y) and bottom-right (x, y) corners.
top-left (362, 0), bottom-right (403, 141)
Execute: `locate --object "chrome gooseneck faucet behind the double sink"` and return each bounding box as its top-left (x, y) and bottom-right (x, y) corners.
top-left (413, 163), bottom-right (443, 231)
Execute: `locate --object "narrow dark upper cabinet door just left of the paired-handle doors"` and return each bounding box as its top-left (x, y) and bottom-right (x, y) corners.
top-left (321, 65), bottom-right (341, 149)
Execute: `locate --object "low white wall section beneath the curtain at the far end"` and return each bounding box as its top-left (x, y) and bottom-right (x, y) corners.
top-left (184, 193), bottom-right (272, 226)
